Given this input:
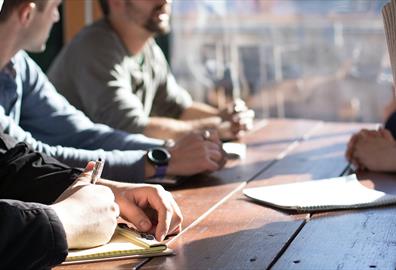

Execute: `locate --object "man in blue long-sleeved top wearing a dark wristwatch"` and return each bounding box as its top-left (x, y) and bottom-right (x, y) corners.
top-left (0, 0), bottom-right (225, 182)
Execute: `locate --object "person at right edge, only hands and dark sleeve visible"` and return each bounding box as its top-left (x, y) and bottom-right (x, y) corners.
top-left (345, 97), bottom-right (396, 172)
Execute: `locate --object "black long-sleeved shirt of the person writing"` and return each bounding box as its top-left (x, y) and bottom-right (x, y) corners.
top-left (0, 133), bottom-right (81, 269)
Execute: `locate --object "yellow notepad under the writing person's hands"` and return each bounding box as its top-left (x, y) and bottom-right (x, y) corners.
top-left (64, 224), bottom-right (173, 264)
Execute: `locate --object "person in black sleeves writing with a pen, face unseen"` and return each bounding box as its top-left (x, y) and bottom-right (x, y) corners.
top-left (0, 130), bottom-right (182, 269)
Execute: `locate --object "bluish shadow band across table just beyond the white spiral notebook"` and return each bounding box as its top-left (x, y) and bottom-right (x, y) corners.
top-left (168, 140), bottom-right (348, 190)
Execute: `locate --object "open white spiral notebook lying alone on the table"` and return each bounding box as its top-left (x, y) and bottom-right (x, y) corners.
top-left (243, 174), bottom-right (396, 212)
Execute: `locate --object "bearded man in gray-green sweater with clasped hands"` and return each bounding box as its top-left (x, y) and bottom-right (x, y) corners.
top-left (48, 0), bottom-right (254, 139)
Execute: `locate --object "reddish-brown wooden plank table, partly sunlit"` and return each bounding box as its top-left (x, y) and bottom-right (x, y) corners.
top-left (57, 119), bottom-right (396, 270)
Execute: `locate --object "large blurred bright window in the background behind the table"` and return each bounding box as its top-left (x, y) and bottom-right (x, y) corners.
top-left (171, 0), bottom-right (393, 122)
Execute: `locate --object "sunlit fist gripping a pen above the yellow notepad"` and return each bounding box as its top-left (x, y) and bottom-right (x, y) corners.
top-left (51, 160), bottom-right (120, 248)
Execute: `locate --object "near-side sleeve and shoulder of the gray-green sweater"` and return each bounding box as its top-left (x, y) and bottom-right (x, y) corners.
top-left (48, 26), bottom-right (148, 133)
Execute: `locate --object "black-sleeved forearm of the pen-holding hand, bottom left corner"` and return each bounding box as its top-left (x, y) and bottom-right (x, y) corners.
top-left (0, 200), bottom-right (67, 269)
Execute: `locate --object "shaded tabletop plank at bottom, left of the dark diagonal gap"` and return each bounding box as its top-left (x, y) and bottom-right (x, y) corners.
top-left (145, 220), bottom-right (304, 269)
